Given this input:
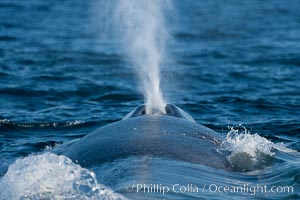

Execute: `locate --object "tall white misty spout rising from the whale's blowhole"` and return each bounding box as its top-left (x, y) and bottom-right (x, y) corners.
top-left (113, 0), bottom-right (171, 114)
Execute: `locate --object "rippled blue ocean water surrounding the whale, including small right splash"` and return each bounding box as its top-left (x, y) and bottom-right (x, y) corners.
top-left (0, 0), bottom-right (300, 200)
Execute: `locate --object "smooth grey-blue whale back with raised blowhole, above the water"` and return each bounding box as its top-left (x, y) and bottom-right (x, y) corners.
top-left (54, 104), bottom-right (230, 169)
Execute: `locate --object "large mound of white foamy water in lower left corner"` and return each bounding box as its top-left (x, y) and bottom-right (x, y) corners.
top-left (0, 152), bottom-right (126, 200)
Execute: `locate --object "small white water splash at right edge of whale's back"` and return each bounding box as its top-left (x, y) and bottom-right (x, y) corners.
top-left (220, 125), bottom-right (294, 171)
